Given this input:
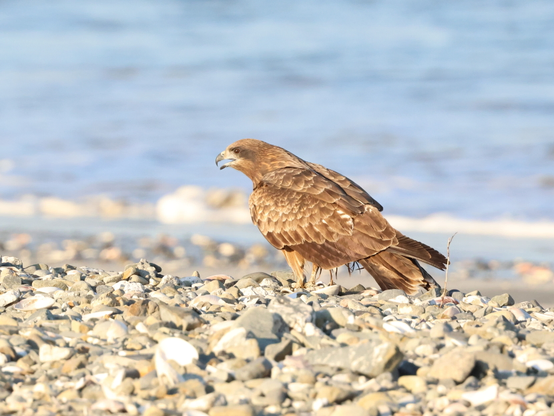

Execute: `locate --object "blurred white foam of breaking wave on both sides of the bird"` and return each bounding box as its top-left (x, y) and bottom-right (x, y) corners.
top-left (0, 185), bottom-right (554, 239)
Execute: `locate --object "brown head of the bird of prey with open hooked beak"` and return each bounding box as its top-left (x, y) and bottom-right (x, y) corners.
top-left (215, 139), bottom-right (300, 184)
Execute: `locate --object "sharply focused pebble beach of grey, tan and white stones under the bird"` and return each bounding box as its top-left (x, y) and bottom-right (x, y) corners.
top-left (0, 250), bottom-right (554, 416)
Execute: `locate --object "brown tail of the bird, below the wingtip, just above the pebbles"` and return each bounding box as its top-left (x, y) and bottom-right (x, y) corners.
top-left (358, 250), bottom-right (440, 295)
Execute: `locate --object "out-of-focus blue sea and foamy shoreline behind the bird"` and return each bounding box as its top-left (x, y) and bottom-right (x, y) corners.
top-left (0, 0), bottom-right (554, 296)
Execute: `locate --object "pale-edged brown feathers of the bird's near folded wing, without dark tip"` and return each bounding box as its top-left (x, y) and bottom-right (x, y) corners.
top-left (249, 168), bottom-right (398, 269)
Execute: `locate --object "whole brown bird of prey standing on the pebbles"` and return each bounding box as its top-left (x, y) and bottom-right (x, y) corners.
top-left (216, 139), bottom-right (446, 294)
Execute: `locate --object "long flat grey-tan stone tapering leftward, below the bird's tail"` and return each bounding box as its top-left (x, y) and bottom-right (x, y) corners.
top-left (304, 341), bottom-right (403, 377)
